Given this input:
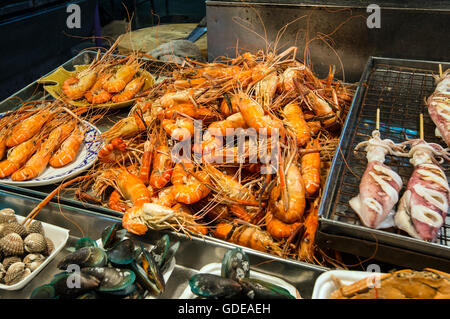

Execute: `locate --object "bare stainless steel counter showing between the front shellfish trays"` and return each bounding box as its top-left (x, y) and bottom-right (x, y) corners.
top-left (0, 191), bottom-right (328, 299)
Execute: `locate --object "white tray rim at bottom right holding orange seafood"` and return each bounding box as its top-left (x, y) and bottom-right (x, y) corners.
top-left (312, 270), bottom-right (383, 299)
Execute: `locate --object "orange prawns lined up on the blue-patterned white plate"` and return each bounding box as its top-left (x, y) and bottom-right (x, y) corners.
top-left (0, 101), bottom-right (87, 181)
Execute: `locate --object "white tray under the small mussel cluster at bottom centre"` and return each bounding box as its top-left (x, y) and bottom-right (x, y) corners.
top-left (179, 263), bottom-right (301, 299)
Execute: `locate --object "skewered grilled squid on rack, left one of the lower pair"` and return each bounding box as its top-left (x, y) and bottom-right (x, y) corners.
top-left (349, 130), bottom-right (403, 229)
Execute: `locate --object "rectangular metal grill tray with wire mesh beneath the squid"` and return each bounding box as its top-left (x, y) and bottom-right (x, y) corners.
top-left (320, 57), bottom-right (450, 258)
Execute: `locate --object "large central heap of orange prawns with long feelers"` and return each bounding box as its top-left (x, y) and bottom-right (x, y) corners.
top-left (30, 48), bottom-right (353, 262)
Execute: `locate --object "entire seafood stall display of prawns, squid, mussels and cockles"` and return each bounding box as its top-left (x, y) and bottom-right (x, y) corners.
top-left (0, 3), bottom-right (450, 300)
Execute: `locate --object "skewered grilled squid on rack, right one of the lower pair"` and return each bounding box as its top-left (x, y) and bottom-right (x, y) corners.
top-left (394, 140), bottom-right (450, 242)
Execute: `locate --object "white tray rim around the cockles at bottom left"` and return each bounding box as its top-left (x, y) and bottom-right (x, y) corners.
top-left (0, 215), bottom-right (69, 290)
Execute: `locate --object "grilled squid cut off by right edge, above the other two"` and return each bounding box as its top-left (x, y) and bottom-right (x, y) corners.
top-left (427, 69), bottom-right (450, 147)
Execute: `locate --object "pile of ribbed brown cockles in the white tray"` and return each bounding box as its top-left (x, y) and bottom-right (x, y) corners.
top-left (0, 208), bottom-right (54, 285)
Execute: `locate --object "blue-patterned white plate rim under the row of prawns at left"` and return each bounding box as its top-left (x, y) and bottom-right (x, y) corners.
top-left (0, 121), bottom-right (103, 187)
